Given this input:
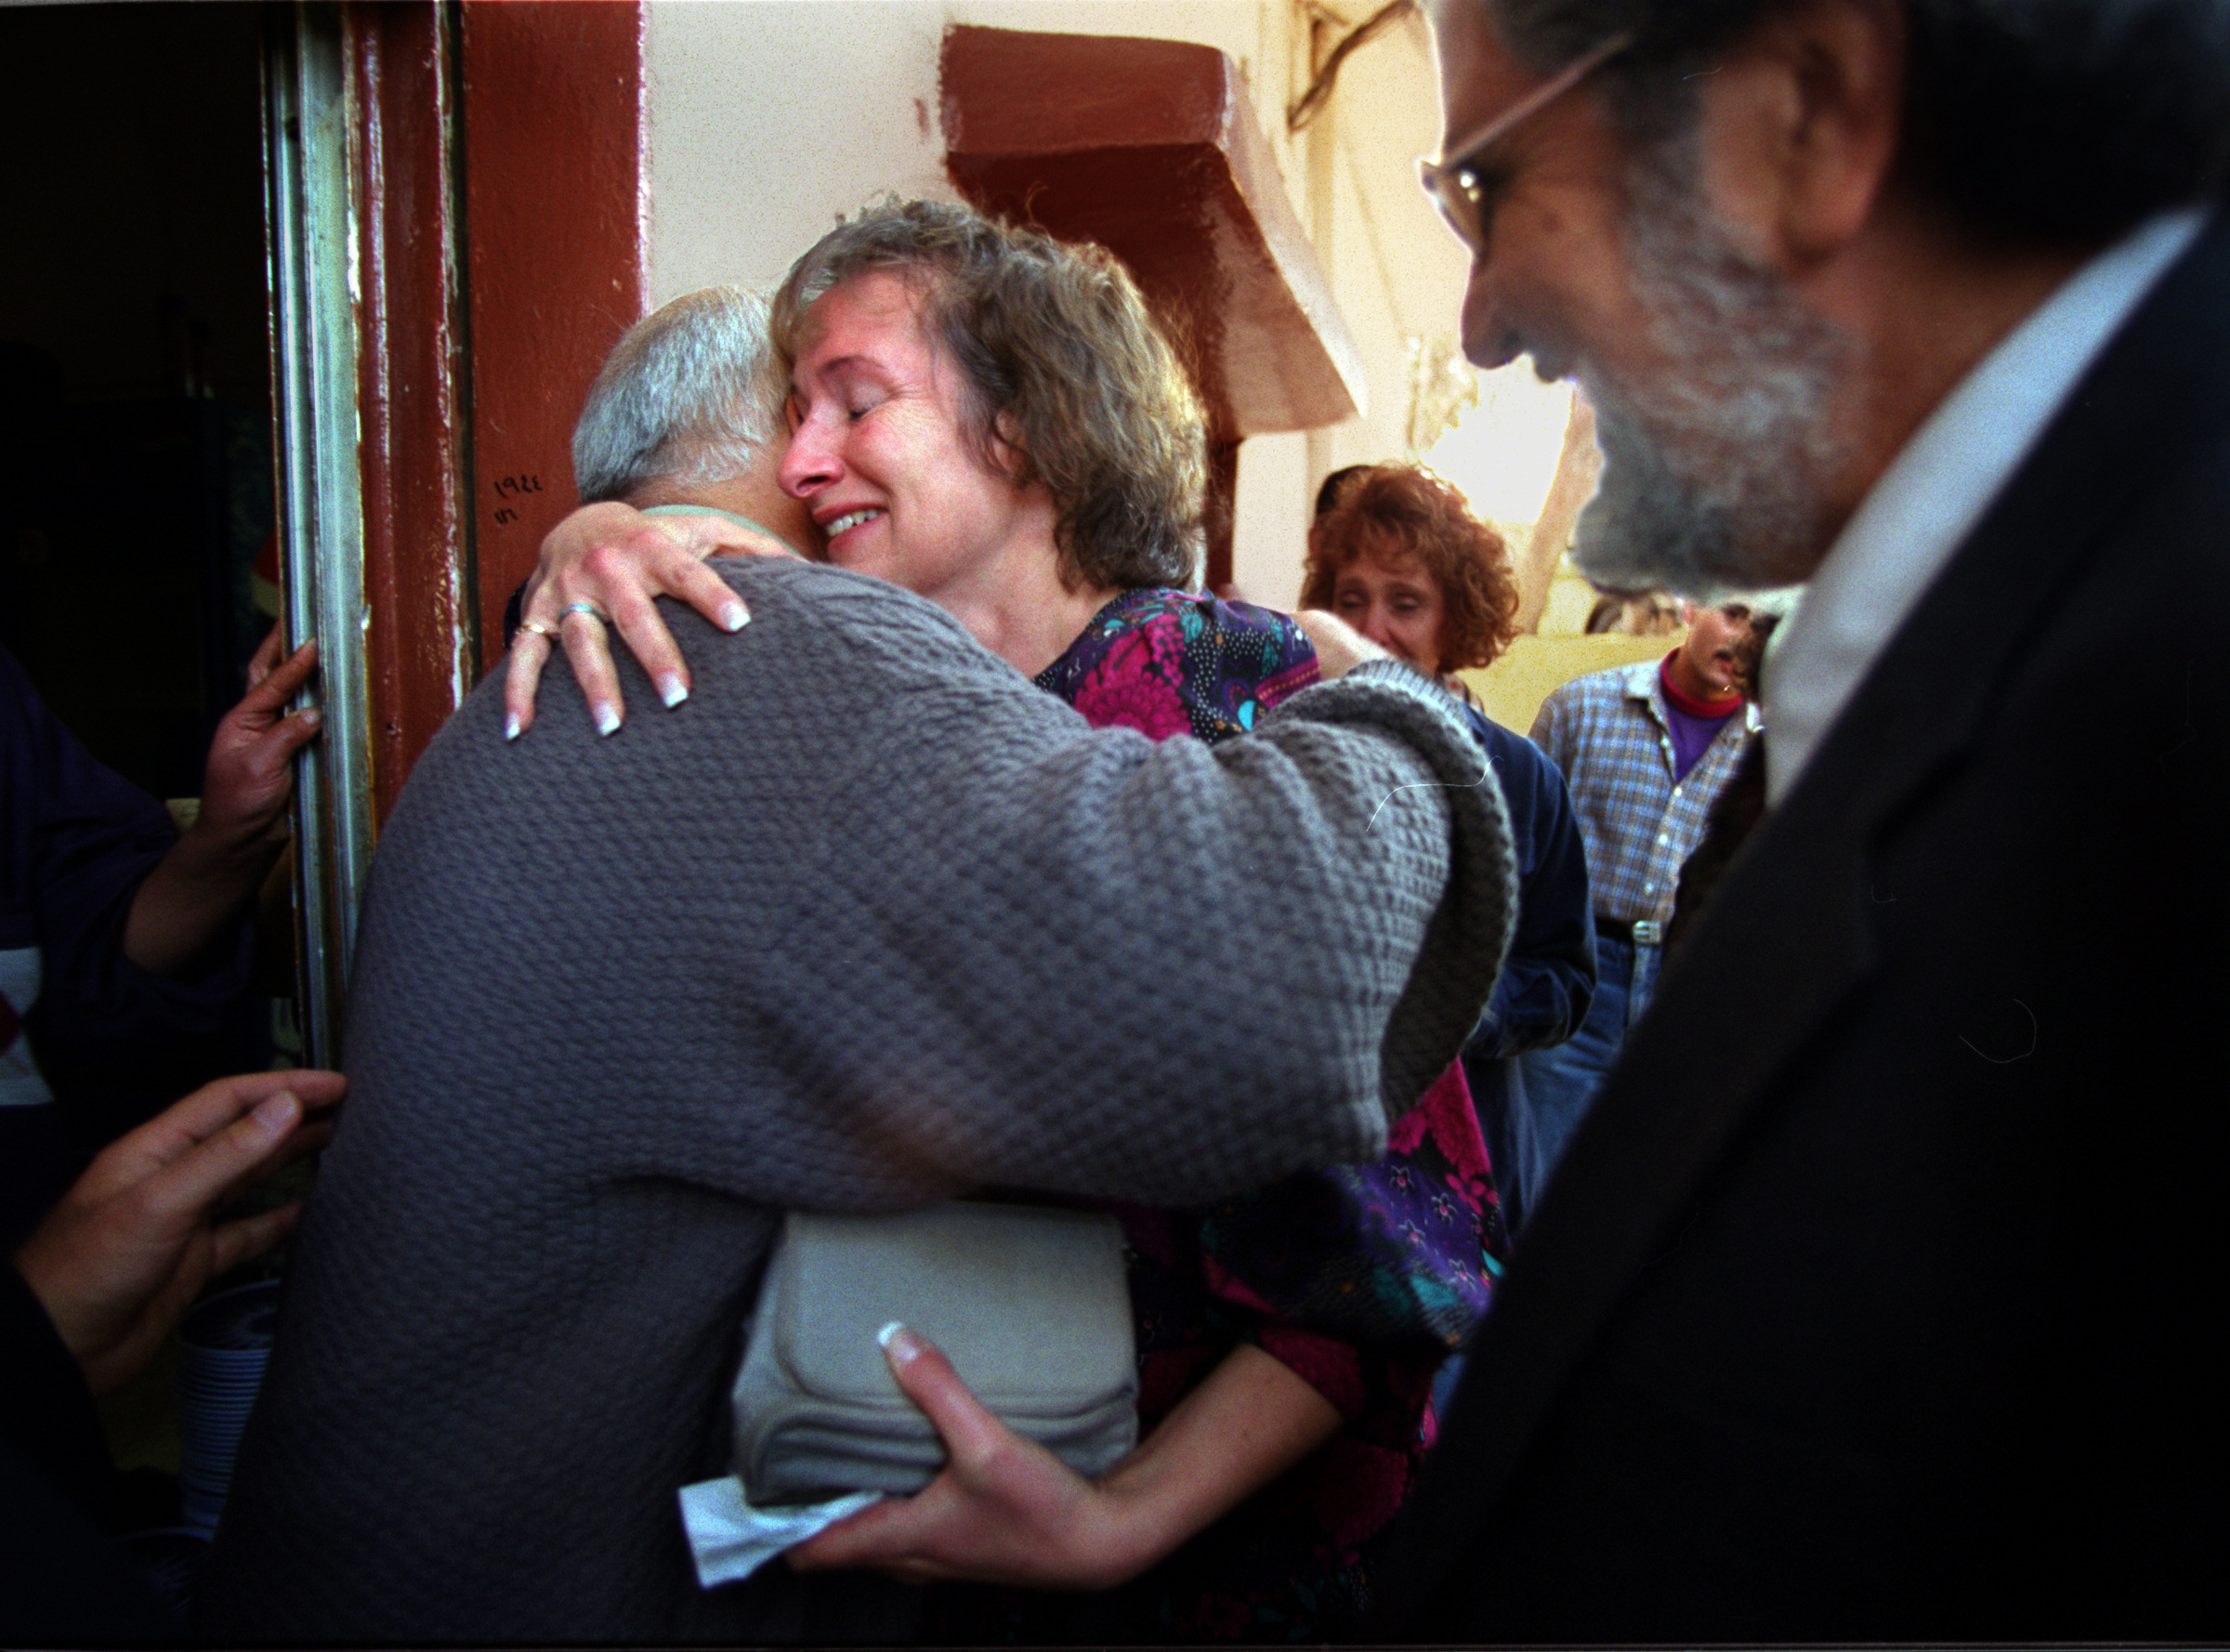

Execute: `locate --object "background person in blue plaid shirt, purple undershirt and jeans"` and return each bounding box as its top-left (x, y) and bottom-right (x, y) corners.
top-left (1496, 602), bottom-right (1764, 1222)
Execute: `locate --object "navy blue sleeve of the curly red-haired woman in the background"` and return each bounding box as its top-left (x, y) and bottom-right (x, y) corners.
top-left (1465, 707), bottom-right (1594, 1061)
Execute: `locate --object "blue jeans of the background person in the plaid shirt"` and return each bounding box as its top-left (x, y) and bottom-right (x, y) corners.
top-left (1488, 934), bottom-right (1663, 1235)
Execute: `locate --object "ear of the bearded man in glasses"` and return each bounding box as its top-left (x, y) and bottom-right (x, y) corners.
top-left (1701, 0), bottom-right (1907, 274)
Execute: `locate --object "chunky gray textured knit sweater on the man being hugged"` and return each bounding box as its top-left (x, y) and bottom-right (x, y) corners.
top-left (203, 562), bottom-right (1515, 1641)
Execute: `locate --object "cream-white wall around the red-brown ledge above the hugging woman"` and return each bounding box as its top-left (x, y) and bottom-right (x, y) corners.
top-left (645, 0), bottom-right (1463, 602)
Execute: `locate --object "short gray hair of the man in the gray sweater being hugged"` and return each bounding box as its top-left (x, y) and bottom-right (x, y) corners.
top-left (573, 288), bottom-right (776, 504)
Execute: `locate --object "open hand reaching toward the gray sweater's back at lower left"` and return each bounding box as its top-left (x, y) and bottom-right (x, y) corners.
top-left (16, 1068), bottom-right (348, 1394)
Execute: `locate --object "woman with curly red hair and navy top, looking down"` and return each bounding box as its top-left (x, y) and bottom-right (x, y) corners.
top-left (1300, 464), bottom-right (1594, 1239)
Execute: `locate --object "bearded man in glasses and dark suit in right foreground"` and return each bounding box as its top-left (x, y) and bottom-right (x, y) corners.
top-left (1378, 0), bottom-right (2230, 1643)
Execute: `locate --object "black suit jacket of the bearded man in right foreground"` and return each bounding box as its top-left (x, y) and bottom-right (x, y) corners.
top-left (1381, 209), bottom-right (2230, 1643)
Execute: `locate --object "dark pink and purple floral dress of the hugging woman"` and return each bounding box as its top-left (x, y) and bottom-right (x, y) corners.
top-left (1008, 588), bottom-right (1503, 1641)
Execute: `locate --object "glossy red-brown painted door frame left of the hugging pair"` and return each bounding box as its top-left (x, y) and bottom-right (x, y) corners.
top-left (348, 0), bottom-right (645, 819)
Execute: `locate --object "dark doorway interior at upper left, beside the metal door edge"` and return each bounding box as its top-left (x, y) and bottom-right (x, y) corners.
top-left (0, 2), bottom-right (272, 798)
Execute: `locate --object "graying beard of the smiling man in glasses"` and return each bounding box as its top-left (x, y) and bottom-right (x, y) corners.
top-left (1572, 154), bottom-right (1851, 602)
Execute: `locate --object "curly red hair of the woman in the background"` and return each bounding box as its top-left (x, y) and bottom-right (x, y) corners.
top-left (1300, 464), bottom-right (1518, 674)
